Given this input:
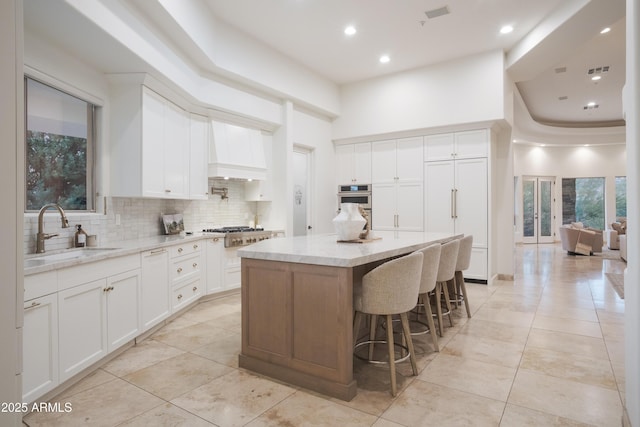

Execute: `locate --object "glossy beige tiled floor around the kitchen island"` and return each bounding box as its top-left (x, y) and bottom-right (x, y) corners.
top-left (25, 245), bottom-right (625, 427)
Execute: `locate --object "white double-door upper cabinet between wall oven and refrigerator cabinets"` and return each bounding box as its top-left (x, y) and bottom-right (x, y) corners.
top-left (371, 136), bottom-right (423, 184)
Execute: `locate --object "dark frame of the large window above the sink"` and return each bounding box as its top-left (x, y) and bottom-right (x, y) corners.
top-left (23, 77), bottom-right (100, 214)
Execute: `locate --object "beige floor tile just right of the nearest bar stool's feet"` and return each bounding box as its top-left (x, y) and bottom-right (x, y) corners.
top-left (418, 354), bottom-right (516, 402)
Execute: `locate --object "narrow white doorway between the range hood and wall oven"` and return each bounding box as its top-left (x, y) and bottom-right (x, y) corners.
top-left (293, 146), bottom-right (313, 236)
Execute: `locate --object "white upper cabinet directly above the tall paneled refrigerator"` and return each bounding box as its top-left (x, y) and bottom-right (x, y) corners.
top-left (424, 129), bottom-right (489, 162)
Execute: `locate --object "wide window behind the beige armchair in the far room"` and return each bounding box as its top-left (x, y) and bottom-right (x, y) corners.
top-left (562, 178), bottom-right (605, 230)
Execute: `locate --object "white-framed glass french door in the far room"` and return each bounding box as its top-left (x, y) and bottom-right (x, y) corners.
top-left (522, 177), bottom-right (555, 243)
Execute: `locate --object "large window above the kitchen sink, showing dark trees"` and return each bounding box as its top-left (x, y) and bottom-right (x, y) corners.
top-left (25, 78), bottom-right (95, 211)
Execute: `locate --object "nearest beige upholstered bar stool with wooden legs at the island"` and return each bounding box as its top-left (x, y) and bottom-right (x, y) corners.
top-left (353, 252), bottom-right (423, 396)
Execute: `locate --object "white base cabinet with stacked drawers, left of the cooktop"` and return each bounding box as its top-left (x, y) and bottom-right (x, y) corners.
top-left (169, 242), bottom-right (203, 313)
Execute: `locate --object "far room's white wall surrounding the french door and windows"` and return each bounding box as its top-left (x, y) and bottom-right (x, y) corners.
top-left (513, 144), bottom-right (627, 241)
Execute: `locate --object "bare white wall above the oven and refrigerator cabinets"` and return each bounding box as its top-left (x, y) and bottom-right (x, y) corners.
top-left (333, 51), bottom-right (505, 140)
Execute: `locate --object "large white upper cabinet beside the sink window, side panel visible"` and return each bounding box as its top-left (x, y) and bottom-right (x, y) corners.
top-left (109, 84), bottom-right (191, 199)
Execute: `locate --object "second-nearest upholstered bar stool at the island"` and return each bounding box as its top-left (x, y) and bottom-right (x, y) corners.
top-left (411, 244), bottom-right (442, 351)
